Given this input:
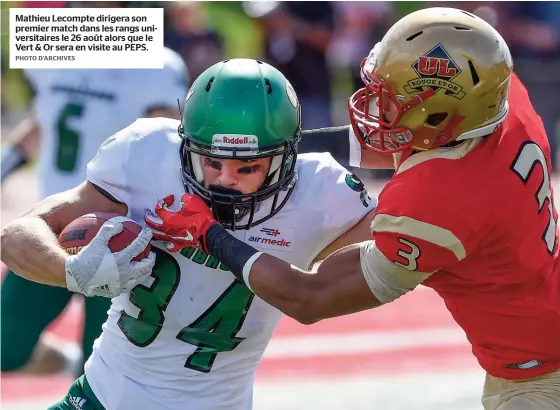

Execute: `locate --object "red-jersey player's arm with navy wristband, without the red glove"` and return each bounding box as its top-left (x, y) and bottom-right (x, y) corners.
top-left (198, 218), bottom-right (398, 324)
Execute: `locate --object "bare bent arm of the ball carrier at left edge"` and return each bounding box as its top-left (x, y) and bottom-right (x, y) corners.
top-left (0, 182), bottom-right (127, 287)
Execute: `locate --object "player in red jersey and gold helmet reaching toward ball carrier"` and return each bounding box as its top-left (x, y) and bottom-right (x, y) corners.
top-left (145, 8), bottom-right (560, 410)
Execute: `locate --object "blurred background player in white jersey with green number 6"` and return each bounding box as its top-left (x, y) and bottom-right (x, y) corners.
top-left (0, 49), bottom-right (188, 374)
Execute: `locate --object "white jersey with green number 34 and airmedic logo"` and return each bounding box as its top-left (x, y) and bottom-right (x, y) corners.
top-left (85, 118), bottom-right (376, 410)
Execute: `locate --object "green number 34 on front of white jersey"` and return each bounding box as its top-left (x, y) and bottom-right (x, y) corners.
top-left (118, 248), bottom-right (254, 373)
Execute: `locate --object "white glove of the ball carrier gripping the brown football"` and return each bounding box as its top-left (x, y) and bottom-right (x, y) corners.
top-left (65, 221), bottom-right (156, 298)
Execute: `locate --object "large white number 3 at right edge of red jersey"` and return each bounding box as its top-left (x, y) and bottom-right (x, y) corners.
top-left (511, 141), bottom-right (557, 255)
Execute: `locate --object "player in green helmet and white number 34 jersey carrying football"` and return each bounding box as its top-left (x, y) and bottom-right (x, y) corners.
top-left (2, 59), bottom-right (376, 410)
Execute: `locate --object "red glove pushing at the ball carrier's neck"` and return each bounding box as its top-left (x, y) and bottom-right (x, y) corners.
top-left (144, 194), bottom-right (218, 252)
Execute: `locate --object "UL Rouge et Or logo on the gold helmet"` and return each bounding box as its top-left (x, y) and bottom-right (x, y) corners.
top-left (404, 44), bottom-right (466, 100)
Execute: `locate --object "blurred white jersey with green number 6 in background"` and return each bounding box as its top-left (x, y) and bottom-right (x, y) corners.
top-left (25, 49), bottom-right (187, 197)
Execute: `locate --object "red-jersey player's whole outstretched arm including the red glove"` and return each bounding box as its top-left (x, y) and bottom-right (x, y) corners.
top-left (145, 194), bottom-right (433, 324)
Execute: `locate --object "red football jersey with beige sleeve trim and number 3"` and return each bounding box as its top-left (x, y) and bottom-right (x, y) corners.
top-left (372, 75), bottom-right (560, 379)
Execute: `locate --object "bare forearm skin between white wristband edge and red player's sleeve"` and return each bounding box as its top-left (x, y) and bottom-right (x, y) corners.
top-left (249, 245), bottom-right (381, 324)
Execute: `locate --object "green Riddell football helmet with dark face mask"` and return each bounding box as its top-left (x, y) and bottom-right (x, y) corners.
top-left (179, 59), bottom-right (301, 230)
